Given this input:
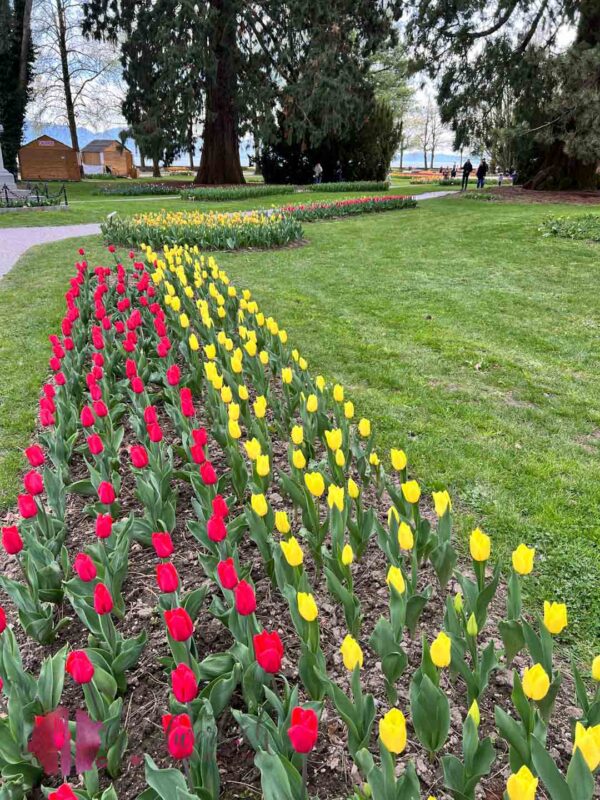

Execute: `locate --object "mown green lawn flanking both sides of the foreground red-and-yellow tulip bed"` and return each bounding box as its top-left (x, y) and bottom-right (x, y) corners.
top-left (0, 195), bottom-right (600, 655)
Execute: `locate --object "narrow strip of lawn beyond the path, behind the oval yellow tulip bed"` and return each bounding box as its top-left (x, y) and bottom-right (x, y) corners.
top-left (0, 179), bottom-right (443, 228)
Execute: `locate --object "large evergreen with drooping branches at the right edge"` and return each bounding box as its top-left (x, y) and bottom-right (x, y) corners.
top-left (405, 0), bottom-right (600, 189)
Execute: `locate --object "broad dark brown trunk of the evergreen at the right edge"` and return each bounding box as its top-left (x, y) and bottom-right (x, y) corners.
top-left (524, 0), bottom-right (600, 191)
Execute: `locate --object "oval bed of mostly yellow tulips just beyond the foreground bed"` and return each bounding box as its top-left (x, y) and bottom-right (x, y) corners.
top-left (102, 209), bottom-right (303, 250)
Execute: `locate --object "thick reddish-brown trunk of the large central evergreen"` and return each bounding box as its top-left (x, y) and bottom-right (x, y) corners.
top-left (195, 0), bottom-right (245, 184)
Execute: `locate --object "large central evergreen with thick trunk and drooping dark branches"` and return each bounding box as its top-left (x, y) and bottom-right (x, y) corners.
top-left (84, 0), bottom-right (399, 183)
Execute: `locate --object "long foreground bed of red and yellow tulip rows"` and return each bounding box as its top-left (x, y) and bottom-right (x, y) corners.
top-left (0, 246), bottom-right (600, 800)
